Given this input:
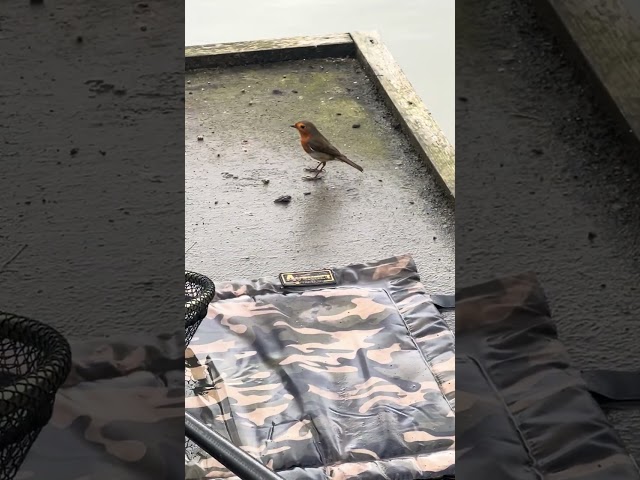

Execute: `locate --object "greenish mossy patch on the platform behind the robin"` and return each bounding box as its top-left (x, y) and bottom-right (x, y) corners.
top-left (186, 59), bottom-right (390, 160)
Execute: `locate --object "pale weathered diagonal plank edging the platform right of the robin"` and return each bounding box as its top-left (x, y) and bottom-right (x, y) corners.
top-left (351, 32), bottom-right (455, 200)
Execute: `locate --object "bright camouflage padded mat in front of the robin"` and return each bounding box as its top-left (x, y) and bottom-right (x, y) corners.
top-left (185, 255), bottom-right (455, 480)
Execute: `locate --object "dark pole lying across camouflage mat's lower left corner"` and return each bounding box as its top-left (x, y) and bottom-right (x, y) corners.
top-left (184, 412), bottom-right (283, 480)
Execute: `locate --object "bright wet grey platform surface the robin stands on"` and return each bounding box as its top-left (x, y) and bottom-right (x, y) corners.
top-left (185, 59), bottom-right (455, 326)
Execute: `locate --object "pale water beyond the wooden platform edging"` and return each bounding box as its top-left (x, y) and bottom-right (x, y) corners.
top-left (185, 0), bottom-right (455, 144)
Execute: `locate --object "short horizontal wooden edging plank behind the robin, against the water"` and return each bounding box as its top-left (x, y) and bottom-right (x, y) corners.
top-left (185, 33), bottom-right (355, 70)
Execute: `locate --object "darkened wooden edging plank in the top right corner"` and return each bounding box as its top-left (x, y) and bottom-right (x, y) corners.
top-left (536, 0), bottom-right (640, 146)
